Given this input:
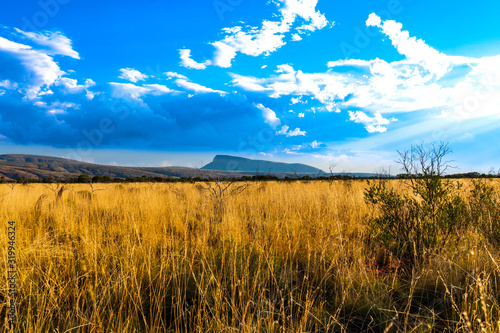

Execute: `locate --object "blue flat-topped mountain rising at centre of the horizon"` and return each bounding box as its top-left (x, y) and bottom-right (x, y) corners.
top-left (202, 155), bottom-right (324, 175)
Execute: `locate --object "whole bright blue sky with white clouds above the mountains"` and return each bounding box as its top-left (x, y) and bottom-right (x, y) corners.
top-left (0, 0), bottom-right (500, 172)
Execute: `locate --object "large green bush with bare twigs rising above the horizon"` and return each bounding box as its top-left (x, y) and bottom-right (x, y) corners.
top-left (365, 143), bottom-right (469, 264)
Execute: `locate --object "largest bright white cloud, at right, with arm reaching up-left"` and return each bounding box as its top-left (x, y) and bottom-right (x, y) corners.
top-left (231, 14), bottom-right (500, 132)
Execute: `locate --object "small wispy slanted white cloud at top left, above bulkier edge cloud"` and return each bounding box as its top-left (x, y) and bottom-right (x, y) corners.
top-left (15, 28), bottom-right (80, 59)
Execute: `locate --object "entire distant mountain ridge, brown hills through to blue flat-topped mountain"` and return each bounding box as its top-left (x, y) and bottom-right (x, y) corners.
top-left (0, 154), bottom-right (374, 180)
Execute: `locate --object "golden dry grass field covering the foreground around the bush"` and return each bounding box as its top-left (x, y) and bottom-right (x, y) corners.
top-left (0, 180), bottom-right (500, 332)
